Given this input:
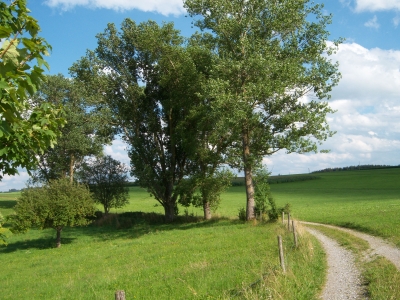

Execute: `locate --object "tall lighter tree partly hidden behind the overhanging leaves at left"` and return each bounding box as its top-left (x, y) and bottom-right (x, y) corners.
top-left (33, 74), bottom-right (113, 182)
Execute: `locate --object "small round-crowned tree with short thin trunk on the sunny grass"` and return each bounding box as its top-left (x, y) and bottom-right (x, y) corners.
top-left (10, 179), bottom-right (95, 248)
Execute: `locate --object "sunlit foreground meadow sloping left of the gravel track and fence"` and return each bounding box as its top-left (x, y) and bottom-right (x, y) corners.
top-left (0, 188), bottom-right (325, 299)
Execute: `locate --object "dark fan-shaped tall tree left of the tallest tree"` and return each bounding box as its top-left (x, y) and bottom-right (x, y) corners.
top-left (71, 19), bottom-right (209, 221)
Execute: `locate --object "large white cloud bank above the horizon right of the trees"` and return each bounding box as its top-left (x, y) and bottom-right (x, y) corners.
top-left (264, 43), bottom-right (400, 175)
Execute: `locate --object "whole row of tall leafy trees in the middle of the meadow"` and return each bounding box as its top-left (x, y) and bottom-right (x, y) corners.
top-left (0, 0), bottom-right (340, 221)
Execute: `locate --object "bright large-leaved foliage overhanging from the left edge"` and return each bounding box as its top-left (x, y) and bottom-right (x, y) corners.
top-left (0, 0), bottom-right (65, 180)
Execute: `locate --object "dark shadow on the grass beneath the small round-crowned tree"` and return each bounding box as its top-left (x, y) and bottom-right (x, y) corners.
top-left (0, 236), bottom-right (75, 254)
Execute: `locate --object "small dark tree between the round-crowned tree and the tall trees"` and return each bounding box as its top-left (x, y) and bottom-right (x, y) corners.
top-left (81, 155), bottom-right (129, 214)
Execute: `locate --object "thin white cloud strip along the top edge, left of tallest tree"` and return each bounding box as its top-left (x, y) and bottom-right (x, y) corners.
top-left (44, 0), bottom-right (185, 15)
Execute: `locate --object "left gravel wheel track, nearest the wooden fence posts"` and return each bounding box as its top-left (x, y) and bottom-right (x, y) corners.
top-left (306, 228), bottom-right (366, 300)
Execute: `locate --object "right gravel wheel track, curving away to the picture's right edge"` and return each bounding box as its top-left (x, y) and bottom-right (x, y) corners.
top-left (301, 222), bottom-right (400, 271)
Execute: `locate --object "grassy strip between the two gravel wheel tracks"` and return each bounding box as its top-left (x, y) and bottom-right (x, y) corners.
top-left (307, 225), bottom-right (400, 300)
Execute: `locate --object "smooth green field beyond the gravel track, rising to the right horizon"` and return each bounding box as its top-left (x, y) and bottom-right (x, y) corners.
top-left (271, 168), bottom-right (400, 246)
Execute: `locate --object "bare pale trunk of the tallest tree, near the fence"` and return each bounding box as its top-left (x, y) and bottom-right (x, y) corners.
top-left (242, 130), bottom-right (255, 220)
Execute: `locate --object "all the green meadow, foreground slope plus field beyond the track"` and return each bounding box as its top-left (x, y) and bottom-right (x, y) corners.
top-left (0, 168), bottom-right (400, 299)
